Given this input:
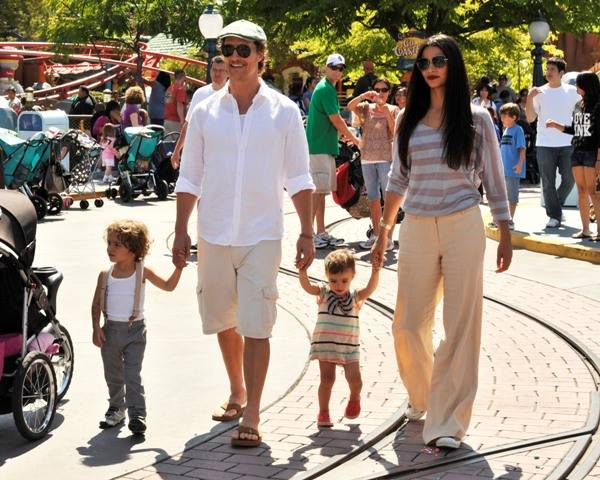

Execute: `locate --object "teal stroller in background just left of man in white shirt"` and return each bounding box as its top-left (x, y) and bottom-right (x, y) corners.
top-left (107, 125), bottom-right (176, 203)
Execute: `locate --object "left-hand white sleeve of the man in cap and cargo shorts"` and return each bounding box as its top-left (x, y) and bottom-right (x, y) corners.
top-left (175, 108), bottom-right (204, 198)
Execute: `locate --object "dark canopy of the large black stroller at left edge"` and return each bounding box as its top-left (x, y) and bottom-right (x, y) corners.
top-left (0, 190), bottom-right (37, 267)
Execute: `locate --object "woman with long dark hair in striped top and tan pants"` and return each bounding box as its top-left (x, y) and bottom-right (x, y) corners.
top-left (371, 35), bottom-right (512, 448)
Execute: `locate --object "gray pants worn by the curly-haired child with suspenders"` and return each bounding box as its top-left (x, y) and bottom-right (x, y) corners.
top-left (101, 320), bottom-right (146, 418)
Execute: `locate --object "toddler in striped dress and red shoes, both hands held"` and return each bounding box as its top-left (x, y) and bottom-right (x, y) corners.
top-left (300, 249), bottom-right (379, 427)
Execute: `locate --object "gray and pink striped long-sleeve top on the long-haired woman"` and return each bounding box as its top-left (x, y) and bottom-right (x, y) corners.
top-left (387, 106), bottom-right (510, 221)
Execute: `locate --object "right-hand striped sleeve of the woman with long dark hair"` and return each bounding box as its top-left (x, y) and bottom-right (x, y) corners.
top-left (474, 110), bottom-right (510, 222)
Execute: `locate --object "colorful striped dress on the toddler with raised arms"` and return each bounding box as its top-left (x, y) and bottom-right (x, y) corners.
top-left (310, 285), bottom-right (360, 365)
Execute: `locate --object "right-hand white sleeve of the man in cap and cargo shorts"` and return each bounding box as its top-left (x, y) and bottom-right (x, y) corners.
top-left (283, 109), bottom-right (315, 197)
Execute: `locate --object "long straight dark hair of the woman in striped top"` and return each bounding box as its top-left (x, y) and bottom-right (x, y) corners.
top-left (396, 35), bottom-right (475, 170)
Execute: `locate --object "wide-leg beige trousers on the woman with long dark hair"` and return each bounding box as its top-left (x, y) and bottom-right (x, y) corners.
top-left (393, 206), bottom-right (485, 443)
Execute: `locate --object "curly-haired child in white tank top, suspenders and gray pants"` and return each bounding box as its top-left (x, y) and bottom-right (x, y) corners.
top-left (92, 220), bottom-right (181, 434)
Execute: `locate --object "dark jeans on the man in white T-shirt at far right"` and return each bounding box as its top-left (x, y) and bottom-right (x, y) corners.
top-left (536, 147), bottom-right (575, 222)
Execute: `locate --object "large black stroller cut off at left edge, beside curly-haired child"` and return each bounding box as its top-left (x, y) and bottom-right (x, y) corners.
top-left (0, 190), bottom-right (74, 441)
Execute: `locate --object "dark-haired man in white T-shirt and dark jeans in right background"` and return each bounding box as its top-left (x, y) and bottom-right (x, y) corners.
top-left (525, 57), bottom-right (581, 228)
